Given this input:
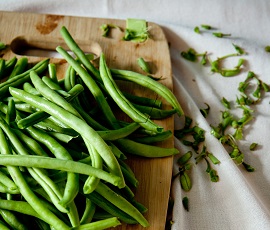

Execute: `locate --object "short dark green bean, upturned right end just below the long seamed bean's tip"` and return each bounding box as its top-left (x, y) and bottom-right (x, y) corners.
top-left (97, 122), bottom-right (140, 141)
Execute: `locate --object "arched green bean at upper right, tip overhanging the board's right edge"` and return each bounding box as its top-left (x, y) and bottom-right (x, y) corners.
top-left (111, 69), bottom-right (184, 116)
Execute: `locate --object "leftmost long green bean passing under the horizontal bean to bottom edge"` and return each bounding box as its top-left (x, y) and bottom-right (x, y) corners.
top-left (0, 126), bottom-right (69, 230)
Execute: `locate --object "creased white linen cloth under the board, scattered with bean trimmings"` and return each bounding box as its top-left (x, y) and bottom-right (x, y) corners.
top-left (0, 0), bottom-right (270, 230)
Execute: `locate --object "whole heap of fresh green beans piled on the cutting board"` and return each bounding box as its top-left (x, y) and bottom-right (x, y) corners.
top-left (0, 27), bottom-right (183, 230)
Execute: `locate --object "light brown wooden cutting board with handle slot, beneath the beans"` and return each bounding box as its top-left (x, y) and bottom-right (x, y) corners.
top-left (0, 12), bottom-right (174, 230)
